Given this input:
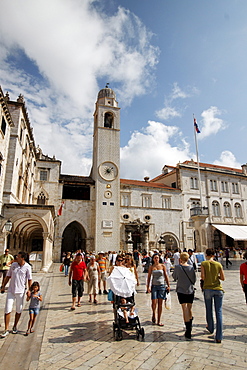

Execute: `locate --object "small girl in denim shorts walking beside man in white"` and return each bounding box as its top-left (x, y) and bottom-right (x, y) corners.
top-left (25, 281), bottom-right (42, 336)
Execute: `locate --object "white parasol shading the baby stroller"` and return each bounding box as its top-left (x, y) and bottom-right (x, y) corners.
top-left (107, 266), bottom-right (136, 298)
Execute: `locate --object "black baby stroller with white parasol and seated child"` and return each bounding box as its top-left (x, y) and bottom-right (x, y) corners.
top-left (108, 266), bottom-right (145, 341)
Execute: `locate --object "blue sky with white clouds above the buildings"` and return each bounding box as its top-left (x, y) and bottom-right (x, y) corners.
top-left (0, 0), bottom-right (247, 179)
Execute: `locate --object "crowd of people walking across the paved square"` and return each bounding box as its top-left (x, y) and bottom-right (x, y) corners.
top-left (0, 248), bottom-right (247, 343)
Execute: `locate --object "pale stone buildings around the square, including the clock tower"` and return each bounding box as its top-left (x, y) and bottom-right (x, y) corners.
top-left (0, 87), bottom-right (247, 271)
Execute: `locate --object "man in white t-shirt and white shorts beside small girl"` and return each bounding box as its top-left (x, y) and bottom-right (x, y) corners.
top-left (1, 252), bottom-right (32, 338)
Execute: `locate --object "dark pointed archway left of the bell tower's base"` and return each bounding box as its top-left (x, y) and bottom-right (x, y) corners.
top-left (61, 221), bottom-right (86, 256)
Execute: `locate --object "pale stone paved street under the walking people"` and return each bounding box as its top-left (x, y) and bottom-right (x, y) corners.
top-left (0, 260), bottom-right (247, 370)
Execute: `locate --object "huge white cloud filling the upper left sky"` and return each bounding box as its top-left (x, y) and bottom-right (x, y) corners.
top-left (0, 0), bottom-right (159, 175)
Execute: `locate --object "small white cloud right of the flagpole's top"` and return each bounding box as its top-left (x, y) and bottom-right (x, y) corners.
top-left (198, 106), bottom-right (226, 139)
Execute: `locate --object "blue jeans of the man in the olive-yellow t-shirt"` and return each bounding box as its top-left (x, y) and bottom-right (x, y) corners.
top-left (204, 289), bottom-right (224, 340)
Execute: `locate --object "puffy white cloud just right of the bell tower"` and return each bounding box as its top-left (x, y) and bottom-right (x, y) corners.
top-left (120, 121), bottom-right (191, 180)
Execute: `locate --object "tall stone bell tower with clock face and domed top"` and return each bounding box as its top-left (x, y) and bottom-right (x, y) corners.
top-left (91, 84), bottom-right (120, 252)
